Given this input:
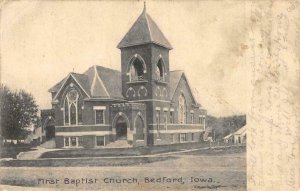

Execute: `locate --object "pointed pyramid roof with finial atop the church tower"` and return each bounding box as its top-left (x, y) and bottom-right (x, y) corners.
top-left (117, 6), bottom-right (172, 49)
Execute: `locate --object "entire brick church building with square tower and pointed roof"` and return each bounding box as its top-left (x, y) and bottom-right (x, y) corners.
top-left (42, 4), bottom-right (206, 148)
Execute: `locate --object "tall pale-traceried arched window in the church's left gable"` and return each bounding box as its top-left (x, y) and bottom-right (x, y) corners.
top-left (64, 89), bottom-right (83, 125)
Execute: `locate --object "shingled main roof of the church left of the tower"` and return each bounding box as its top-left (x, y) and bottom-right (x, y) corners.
top-left (49, 65), bottom-right (124, 99)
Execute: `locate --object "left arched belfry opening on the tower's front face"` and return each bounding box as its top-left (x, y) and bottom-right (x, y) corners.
top-left (129, 56), bottom-right (146, 81)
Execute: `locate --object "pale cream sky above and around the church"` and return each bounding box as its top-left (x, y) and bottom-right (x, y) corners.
top-left (1, 0), bottom-right (250, 116)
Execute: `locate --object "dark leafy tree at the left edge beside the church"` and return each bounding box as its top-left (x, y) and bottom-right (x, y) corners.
top-left (0, 85), bottom-right (39, 140)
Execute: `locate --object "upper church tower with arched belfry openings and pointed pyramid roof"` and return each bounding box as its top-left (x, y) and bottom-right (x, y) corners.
top-left (117, 3), bottom-right (172, 101)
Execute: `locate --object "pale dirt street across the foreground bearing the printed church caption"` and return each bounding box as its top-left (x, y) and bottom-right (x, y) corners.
top-left (0, 152), bottom-right (246, 191)
